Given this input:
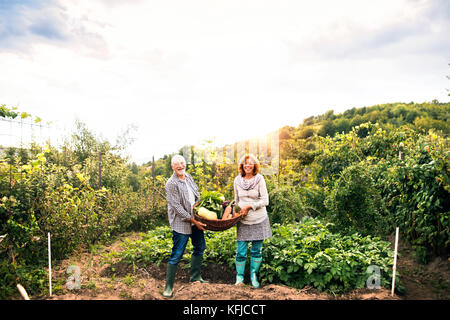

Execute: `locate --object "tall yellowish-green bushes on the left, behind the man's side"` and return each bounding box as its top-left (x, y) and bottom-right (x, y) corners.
top-left (0, 115), bottom-right (167, 298)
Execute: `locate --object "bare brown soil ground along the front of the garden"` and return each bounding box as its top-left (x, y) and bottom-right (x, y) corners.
top-left (32, 233), bottom-right (450, 300)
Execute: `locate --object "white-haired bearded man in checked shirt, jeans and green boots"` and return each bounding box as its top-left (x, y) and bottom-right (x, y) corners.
top-left (163, 155), bottom-right (207, 297)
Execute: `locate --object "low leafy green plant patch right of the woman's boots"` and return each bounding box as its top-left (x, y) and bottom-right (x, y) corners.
top-left (260, 218), bottom-right (402, 293)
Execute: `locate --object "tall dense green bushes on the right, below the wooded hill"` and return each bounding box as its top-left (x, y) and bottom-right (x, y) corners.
top-left (316, 124), bottom-right (450, 263)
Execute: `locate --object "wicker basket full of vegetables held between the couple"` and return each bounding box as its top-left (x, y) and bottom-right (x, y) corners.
top-left (194, 191), bottom-right (242, 231)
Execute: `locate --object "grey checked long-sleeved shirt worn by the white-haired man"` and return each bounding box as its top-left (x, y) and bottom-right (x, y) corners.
top-left (166, 173), bottom-right (200, 234)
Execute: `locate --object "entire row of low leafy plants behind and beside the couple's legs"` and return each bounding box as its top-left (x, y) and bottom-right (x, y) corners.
top-left (105, 218), bottom-right (402, 293)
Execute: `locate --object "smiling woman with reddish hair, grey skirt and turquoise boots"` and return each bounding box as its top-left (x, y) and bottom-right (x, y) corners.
top-left (234, 154), bottom-right (272, 288)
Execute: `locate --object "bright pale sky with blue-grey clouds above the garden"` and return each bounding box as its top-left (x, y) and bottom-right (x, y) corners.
top-left (0, 0), bottom-right (450, 164)
